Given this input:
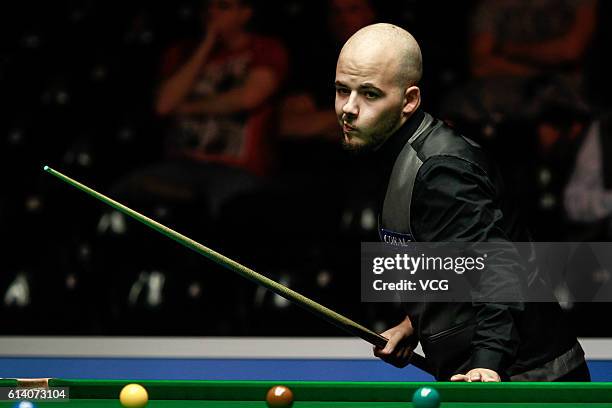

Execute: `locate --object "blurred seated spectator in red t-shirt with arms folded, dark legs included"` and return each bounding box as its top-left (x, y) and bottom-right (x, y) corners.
top-left (114, 0), bottom-right (287, 215)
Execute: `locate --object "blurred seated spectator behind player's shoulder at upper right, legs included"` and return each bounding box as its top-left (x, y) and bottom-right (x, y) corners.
top-left (440, 0), bottom-right (597, 241)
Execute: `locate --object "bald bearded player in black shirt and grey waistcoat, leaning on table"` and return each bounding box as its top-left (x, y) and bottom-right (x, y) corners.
top-left (335, 24), bottom-right (590, 381)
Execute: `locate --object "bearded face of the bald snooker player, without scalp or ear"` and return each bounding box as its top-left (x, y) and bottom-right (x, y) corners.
top-left (335, 52), bottom-right (405, 151)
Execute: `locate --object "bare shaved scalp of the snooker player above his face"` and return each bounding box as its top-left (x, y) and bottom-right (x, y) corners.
top-left (338, 23), bottom-right (423, 86)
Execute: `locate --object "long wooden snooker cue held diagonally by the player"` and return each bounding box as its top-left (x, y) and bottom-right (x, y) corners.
top-left (43, 166), bottom-right (431, 374)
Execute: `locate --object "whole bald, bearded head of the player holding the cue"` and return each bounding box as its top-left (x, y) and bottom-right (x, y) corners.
top-left (335, 24), bottom-right (421, 151)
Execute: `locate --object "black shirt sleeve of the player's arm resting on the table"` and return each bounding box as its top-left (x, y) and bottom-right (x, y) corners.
top-left (411, 156), bottom-right (525, 376)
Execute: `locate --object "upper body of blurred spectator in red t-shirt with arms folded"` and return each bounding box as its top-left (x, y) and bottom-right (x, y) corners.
top-left (156, 0), bottom-right (287, 174)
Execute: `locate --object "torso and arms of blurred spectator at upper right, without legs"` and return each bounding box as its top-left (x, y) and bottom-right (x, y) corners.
top-left (442, 0), bottom-right (597, 122)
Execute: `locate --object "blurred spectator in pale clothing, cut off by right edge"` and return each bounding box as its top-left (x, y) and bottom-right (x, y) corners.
top-left (565, 113), bottom-right (612, 241)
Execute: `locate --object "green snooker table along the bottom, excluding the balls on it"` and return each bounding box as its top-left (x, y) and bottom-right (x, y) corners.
top-left (0, 379), bottom-right (612, 408)
